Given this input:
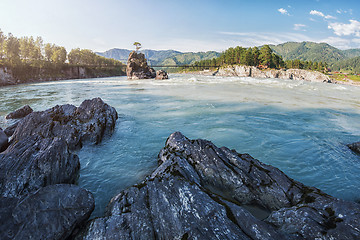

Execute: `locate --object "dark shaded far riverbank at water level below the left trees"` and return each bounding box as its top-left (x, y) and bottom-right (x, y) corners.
top-left (0, 65), bottom-right (125, 87)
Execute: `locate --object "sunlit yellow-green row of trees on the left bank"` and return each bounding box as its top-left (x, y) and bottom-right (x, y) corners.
top-left (0, 29), bottom-right (125, 80)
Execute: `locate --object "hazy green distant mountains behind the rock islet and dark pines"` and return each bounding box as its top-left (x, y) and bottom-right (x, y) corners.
top-left (96, 42), bottom-right (360, 73)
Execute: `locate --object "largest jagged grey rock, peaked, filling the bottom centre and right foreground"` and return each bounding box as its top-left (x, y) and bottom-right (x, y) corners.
top-left (77, 132), bottom-right (360, 239)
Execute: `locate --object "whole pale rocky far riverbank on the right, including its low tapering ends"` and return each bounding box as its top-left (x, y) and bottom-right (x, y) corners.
top-left (188, 65), bottom-right (360, 86)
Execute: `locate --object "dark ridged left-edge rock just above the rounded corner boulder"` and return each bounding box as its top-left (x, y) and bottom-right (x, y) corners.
top-left (0, 136), bottom-right (80, 197)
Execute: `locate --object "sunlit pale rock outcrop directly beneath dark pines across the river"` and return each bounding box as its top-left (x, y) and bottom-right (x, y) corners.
top-left (212, 65), bottom-right (334, 83)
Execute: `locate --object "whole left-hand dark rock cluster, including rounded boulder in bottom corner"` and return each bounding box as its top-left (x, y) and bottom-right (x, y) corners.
top-left (0, 98), bottom-right (118, 239)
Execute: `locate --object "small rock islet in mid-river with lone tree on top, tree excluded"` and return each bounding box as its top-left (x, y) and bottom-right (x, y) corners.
top-left (126, 51), bottom-right (156, 79)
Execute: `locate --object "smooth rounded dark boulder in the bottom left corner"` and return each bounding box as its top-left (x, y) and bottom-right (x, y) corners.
top-left (0, 184), bottom-right (95, 240)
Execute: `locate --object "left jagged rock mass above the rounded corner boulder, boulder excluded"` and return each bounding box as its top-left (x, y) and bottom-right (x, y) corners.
top-left (0, 98), bottom-right (117, 197)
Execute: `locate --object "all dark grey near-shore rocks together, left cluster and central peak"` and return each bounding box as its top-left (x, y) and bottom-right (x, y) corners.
top-left (0, 98), bottom-right (360, 240)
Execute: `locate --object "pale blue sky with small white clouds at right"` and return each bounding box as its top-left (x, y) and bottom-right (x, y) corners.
top-left (0, 0), bottom-right (360, 51)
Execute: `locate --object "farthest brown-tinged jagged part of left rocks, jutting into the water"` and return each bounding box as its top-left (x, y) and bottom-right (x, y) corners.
top-left (12, 98), bottom-right (118, 149)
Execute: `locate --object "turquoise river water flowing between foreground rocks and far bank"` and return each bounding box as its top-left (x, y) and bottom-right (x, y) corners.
top-left (0, 74), bottom-right (360, 216)
